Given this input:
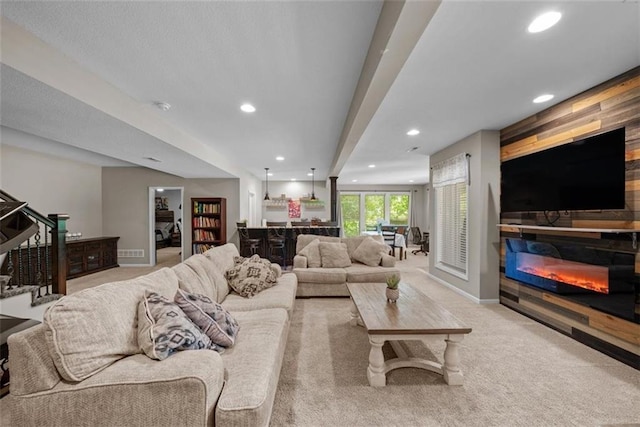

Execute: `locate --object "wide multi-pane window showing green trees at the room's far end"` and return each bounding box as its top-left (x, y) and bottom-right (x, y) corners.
top-left (340, 192), bottom-right (411, 236)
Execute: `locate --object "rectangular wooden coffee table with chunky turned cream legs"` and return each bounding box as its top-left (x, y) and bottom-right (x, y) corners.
top-left (347, 283), bottom-right (471, 387)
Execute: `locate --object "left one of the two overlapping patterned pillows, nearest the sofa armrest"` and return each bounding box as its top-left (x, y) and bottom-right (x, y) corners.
top-left (138, 291), bottom-right (221, 360)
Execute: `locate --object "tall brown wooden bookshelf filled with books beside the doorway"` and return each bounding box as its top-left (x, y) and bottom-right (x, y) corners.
top-left (191, 197), bottom-right (227, 254)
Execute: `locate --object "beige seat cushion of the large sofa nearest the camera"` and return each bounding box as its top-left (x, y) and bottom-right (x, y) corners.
top-left (215, 309), bottom-right (289, 426)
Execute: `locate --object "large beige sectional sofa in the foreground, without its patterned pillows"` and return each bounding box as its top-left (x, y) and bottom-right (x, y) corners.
top-left (6, 244), bottom-right (297, 427)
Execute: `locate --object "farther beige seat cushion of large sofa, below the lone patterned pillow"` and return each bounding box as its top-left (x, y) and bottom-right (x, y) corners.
top-left (222, 273), bottom-right (298, 314)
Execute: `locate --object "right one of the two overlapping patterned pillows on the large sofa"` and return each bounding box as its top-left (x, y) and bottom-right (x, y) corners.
top-left (175, 289), bottom-right (240, 347)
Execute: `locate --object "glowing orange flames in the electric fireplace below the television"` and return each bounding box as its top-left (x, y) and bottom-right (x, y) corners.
top-left (516, 252), bottom-right (609, 294)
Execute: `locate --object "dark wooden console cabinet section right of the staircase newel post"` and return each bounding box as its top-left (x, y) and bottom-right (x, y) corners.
top-left (67, 237), bottom-right (120, 279)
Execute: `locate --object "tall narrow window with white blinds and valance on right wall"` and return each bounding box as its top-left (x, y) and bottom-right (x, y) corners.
top-left (432, 153), bottom-right (468, 279)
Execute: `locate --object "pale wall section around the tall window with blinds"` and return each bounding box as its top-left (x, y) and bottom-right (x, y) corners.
top-left (429, 131), bottom-right (500, 302)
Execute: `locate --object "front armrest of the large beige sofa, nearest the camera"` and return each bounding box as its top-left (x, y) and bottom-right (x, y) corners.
top-left (8, 350), bottom-right (225, 426)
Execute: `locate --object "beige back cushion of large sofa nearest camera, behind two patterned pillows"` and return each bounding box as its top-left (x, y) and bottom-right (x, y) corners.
top-left (43, 268), bottom-right (178, 381)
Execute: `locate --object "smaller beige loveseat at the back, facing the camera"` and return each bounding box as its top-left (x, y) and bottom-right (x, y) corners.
top-left (293, 234), bottom-right (400, 297)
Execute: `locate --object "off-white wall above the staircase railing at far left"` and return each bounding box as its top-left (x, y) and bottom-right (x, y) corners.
top-left (0, 144), bottom-right (102, 238)
